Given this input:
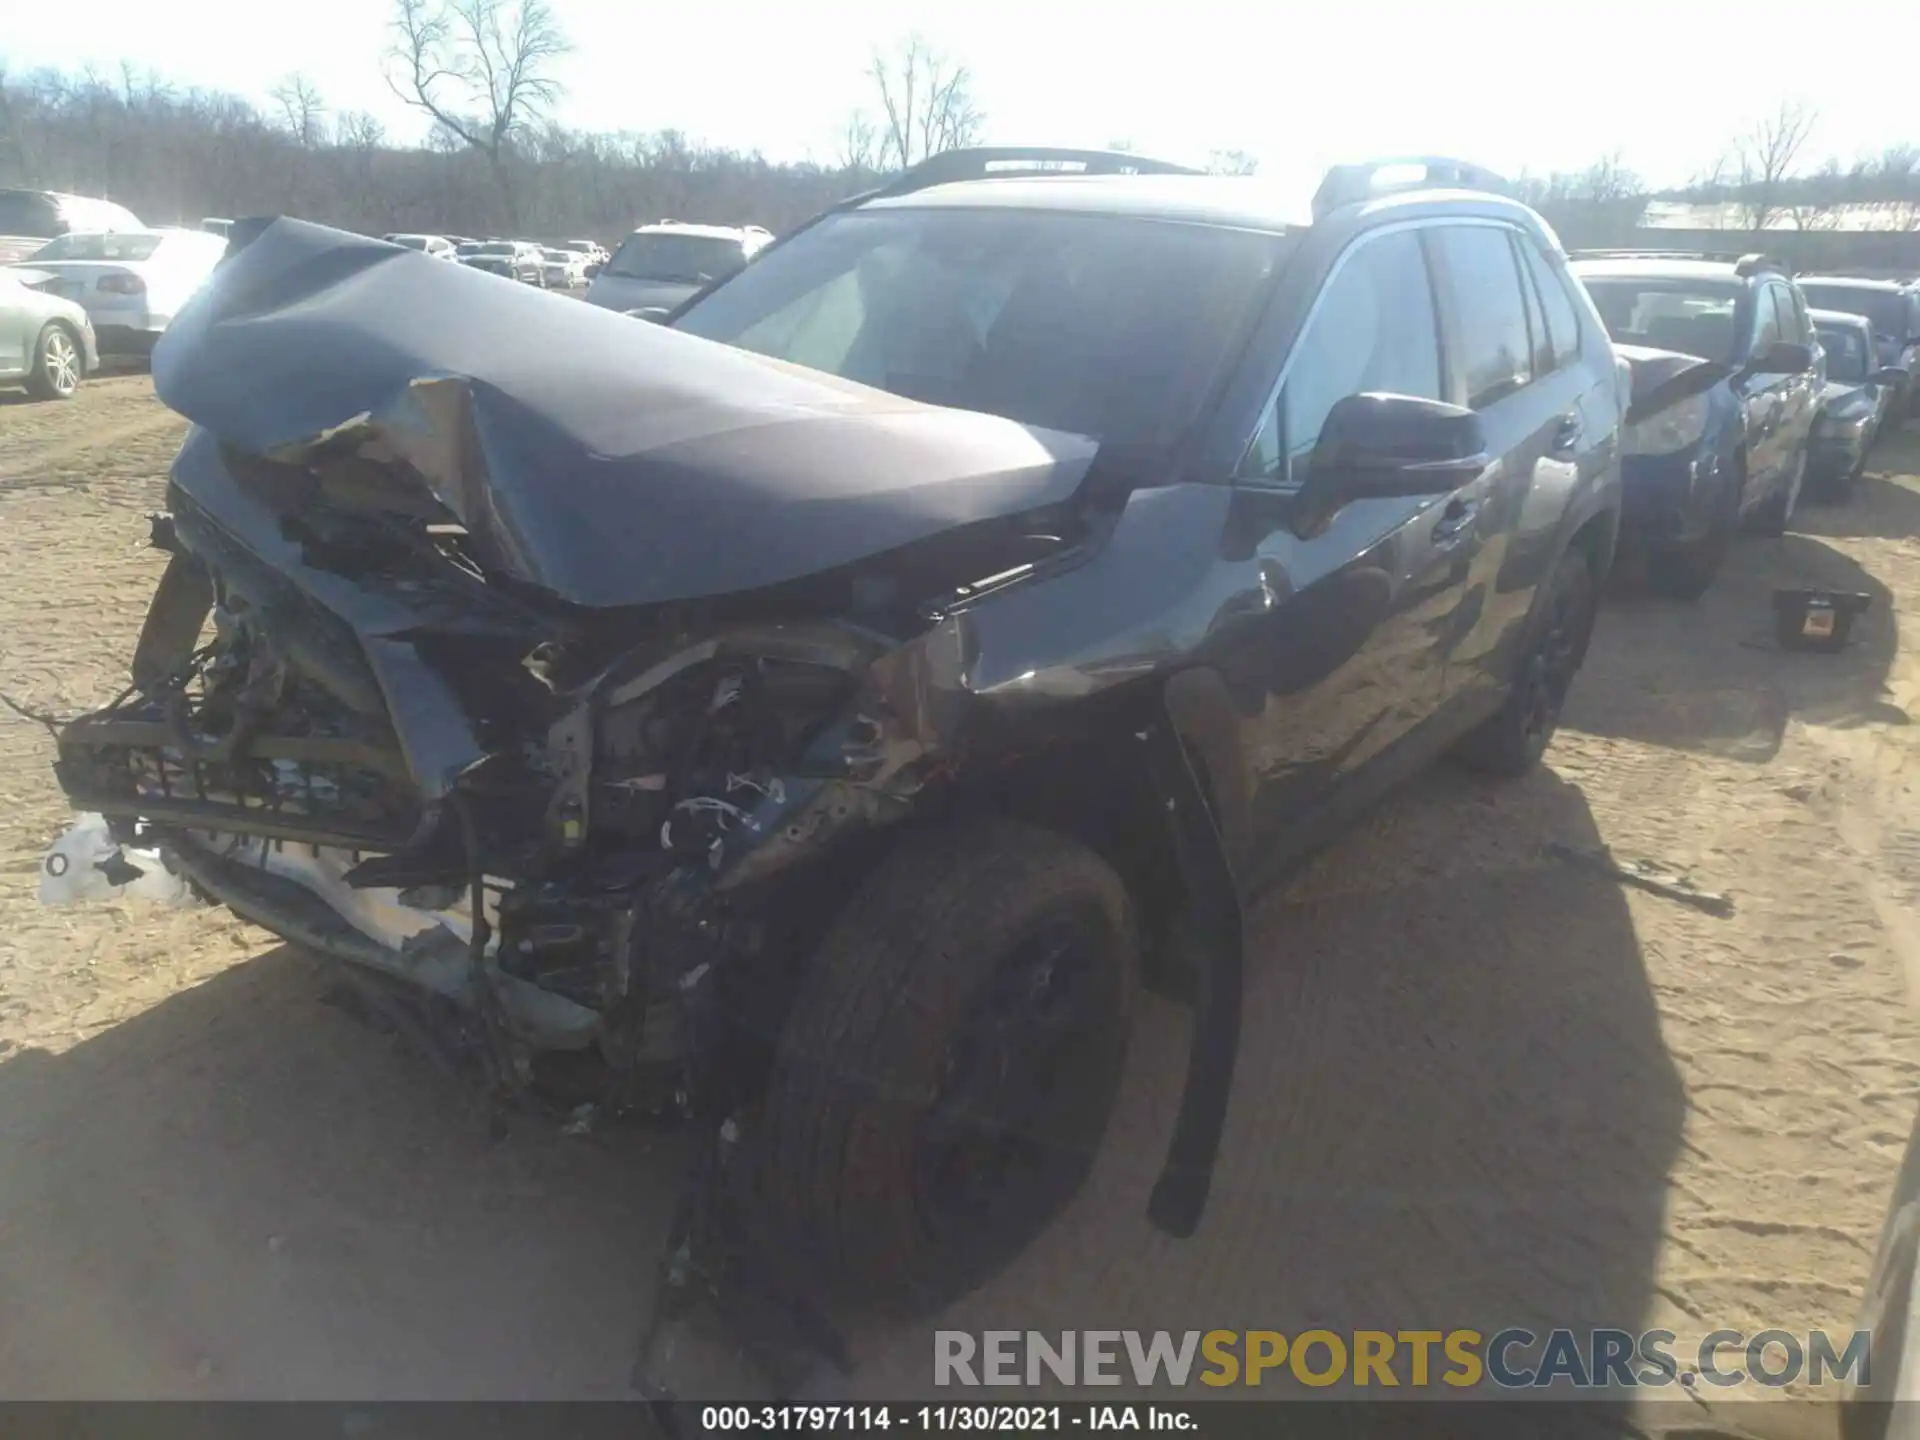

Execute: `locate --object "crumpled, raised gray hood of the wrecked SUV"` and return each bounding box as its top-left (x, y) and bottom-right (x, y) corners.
top-left (154, 219), bottom-right (1096, 607)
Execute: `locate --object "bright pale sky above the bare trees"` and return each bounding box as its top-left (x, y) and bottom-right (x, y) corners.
top-left (0, 0), bottom-right (1920, 203)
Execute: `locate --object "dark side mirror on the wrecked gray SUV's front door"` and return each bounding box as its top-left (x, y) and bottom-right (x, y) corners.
top-left (1294, 394), bottom-right (1492, 536)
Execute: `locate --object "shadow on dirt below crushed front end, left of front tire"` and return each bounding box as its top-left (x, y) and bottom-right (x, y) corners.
top-left (0, 947), bottom-right (684, 1400)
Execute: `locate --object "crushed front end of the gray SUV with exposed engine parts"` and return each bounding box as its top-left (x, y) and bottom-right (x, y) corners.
top-left (58, 497), bottom-right (967, 1114)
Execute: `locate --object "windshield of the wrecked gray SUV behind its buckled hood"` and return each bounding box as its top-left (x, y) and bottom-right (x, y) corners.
top-left (676, 209), bottom-right (1286, 459)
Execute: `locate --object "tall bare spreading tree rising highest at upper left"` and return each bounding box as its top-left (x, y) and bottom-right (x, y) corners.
top-left (388, 0), bottom-right (572, 227)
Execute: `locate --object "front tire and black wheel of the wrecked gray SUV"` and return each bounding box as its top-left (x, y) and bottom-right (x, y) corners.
top-left (760, 822), bottom-right (1139, 1313)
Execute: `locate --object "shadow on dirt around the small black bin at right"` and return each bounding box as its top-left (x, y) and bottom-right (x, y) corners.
top-left (1565, 533), bottom-right (1907, 762)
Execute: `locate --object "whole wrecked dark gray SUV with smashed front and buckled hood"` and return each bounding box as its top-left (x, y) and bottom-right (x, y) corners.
top-left (58, 152), bottom-right (1624, 1351)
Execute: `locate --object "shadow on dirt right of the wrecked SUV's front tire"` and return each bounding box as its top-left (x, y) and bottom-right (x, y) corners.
top-left (854, 770), bottom-right (1684, 1400)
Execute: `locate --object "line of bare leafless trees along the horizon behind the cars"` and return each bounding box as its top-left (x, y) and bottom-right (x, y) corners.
top-left (11, 0), bottom-right (1920, 240)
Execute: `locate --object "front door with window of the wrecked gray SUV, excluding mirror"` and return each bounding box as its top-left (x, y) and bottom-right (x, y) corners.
top-left (1215, 228), bottom-right (1484, 889)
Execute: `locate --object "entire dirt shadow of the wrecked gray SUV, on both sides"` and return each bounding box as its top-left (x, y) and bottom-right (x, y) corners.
top-left (0, 772), bottom-right (1682, 1400)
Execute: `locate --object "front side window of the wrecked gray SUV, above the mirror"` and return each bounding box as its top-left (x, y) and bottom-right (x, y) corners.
top-left (1238, 230), bottom-right (1442, 484)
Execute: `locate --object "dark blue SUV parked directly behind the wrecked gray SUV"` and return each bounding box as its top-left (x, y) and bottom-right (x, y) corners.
top-left (1572, 250), bottom-right (1820, 599)
